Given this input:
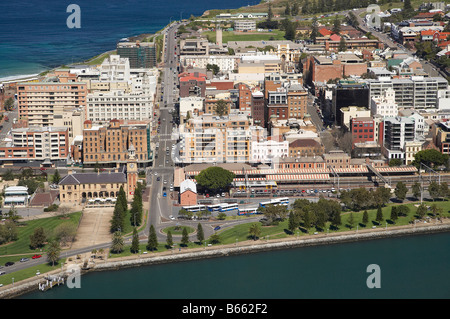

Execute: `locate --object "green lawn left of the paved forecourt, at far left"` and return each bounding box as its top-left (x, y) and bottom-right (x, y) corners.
top-left (0, 212), bottom-right (81, 259)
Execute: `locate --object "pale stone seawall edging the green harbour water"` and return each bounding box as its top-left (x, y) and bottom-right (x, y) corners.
top-left (0, 220), bottom-right (450, 299)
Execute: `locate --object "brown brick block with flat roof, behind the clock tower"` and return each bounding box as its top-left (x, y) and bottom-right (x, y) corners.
top-left (83, 119), bottom-right (152, 167)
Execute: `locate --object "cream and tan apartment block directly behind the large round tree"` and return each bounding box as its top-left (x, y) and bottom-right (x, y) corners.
top-left (179, 114), bottom-right (255, 163)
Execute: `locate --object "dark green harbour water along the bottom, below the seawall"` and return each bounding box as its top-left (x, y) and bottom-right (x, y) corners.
top-left (22, 233), bottom-right (450, 299)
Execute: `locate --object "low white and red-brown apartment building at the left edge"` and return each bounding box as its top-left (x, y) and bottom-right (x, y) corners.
top-left (0, 126), bottom-right (70, 161)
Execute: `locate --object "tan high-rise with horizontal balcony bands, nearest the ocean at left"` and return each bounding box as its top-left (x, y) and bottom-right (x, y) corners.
top-left (17, 71), bottom-right (87, 126)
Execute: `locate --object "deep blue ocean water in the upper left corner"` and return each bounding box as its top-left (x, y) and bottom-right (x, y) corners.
top-left (0, 0), bottom-right (256, 79)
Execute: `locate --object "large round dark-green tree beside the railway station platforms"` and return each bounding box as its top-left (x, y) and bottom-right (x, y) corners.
top-left (195, 166), bottom-right (235, 192)
